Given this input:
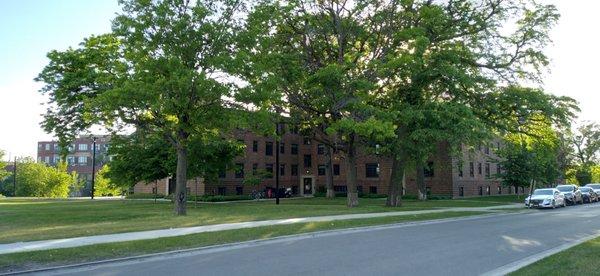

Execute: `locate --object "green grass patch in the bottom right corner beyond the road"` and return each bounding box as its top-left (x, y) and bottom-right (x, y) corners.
top-left (510, 235), bottom-right (600, 276)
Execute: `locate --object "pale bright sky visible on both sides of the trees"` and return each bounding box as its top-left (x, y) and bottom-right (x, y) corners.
top-left (0, 0), bottom-right (600, 160)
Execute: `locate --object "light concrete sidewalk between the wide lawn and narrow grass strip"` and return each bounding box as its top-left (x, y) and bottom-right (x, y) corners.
top-left (0, 204), bottom-right (523, 254)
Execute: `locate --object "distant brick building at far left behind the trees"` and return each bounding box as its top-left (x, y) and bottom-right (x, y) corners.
top-left (37, 135), bottom-right (110, 196)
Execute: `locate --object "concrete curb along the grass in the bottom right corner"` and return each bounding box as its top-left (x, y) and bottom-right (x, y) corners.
top-left (481, 231), bottom-right (600, 276)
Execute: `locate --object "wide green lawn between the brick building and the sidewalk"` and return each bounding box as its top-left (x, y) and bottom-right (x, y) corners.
top-left (0, 198), bottom-right (510, 243)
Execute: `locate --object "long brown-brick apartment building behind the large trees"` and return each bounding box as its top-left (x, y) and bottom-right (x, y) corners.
top-left (132, 128), bottom-right (525, 198)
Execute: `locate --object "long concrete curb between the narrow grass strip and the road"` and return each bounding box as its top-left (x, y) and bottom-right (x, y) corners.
top-left (0, 213), bottom-right (515, 276)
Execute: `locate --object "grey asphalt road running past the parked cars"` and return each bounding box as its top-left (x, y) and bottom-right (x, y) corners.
top-left (39, 204), bottom-right (600, 276)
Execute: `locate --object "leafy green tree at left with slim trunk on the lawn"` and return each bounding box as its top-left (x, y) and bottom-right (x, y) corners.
top-left (37, 0), bottom-right (246, 215)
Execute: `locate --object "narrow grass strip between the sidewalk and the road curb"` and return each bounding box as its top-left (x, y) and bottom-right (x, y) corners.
top-left (0, 212), bottom-right (483, 273)
